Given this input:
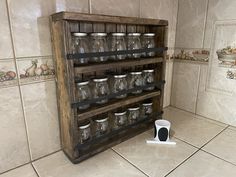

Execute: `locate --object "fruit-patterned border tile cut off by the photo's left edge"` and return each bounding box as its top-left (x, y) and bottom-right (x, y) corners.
top-left (0, 59), bottom-right (17, 88)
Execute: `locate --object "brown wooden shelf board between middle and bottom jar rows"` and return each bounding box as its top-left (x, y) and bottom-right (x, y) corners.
top-left (78, 90), bottom-right (161, 121)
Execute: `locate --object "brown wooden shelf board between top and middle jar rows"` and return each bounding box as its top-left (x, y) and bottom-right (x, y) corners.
top-left (75, 57), bottom-right (164, 74)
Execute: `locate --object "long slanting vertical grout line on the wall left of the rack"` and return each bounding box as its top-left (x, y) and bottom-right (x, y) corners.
top-left (5, 0), bottom-right (31, 161)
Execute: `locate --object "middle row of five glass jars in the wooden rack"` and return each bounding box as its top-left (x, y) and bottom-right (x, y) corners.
top-left (77, 69), bottom-right (155, 110)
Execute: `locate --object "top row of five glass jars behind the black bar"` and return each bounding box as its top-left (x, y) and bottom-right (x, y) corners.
top-left (72, 33), bottom-right (156, 64)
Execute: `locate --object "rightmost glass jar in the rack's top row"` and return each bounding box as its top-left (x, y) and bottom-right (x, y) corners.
top-left (142, 33), bottom-right (156, 57)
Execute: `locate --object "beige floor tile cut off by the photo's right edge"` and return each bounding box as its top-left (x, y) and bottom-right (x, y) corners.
top-left (203, 128), bottom-right (236, 165)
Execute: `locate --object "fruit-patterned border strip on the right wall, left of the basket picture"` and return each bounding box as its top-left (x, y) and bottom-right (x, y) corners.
top-left (173, 49), bottom-right (210, 62)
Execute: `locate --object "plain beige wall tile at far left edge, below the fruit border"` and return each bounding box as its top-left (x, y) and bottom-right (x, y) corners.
top-left (0, 87), bottom-right (30, 173)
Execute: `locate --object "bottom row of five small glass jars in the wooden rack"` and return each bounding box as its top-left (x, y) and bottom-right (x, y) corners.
top-left (78, 100), bottom-right (153, 144)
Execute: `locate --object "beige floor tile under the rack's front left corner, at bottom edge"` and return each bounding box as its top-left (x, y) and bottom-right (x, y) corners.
top-left (33, 150), bottom-right (145, 177)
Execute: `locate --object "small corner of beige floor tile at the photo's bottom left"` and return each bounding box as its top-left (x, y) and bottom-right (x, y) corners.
top-left (0, 164), bottom-right (37, 177)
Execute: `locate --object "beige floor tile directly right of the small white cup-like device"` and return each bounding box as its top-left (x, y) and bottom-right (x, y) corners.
top-left (163, 107), bottom-right (227, 147)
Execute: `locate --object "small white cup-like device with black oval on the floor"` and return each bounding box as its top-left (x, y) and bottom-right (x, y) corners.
top-left (146, 119), bottom-right (176, 145)
